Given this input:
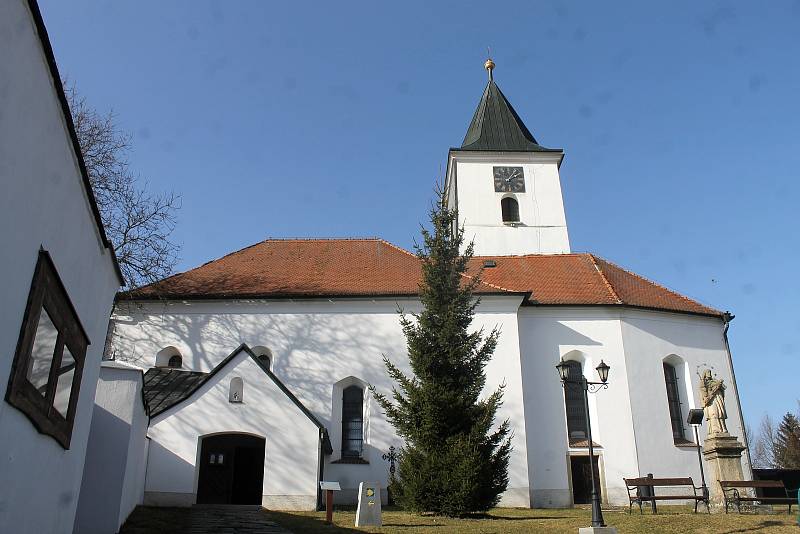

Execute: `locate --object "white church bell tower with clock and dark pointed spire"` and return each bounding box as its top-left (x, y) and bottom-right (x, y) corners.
top-left (445, 59), bottom-right (570, 256)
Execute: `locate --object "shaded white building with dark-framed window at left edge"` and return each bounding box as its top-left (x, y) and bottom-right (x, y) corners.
top-left (0, 0), bottom-right (121, 534)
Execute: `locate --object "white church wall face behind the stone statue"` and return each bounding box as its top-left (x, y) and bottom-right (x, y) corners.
top-left (622, 310), bottom-right (752, 485)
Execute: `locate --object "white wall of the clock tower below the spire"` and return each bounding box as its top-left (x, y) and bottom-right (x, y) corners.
top-left (448, 152), bottom-right (570, 255)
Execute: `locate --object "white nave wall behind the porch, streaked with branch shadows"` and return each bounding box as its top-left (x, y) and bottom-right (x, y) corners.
top-left (112, 297), bottom-right (530, 506)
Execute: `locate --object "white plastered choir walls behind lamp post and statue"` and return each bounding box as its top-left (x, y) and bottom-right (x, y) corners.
top-left (520, 306), bottom-right (749, 507)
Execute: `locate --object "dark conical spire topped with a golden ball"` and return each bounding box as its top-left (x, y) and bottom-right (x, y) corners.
top-left (461, 59), bottom-right (557, 152)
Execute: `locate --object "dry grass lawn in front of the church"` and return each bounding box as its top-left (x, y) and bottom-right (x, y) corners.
top-left (266, 506), bottom-right (800, 534)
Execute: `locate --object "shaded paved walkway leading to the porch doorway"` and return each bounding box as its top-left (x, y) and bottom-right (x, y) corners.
top-left (120, 506), bottom-right (291, 534)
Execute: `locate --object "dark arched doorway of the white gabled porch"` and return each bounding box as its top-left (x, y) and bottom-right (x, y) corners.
top-left (197, 434), bottom-right (266, 504)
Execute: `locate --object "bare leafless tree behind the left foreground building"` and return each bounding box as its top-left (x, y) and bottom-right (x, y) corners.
top-left (62, 81), bottom-right (180, 287)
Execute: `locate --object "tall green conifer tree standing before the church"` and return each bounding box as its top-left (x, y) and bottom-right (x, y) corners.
top-left (371, 190), bottom-right (511, 516)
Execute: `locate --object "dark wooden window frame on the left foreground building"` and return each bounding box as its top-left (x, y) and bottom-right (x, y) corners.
top-left (6, 249), bottom-right (90, 449)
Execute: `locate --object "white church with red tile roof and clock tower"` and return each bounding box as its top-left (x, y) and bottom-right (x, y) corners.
top-left (104, 60), bottom-right (750, 510)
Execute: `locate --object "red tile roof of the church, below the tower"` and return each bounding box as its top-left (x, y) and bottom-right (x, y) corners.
top-left (120, 239), bottom-right (722, 316)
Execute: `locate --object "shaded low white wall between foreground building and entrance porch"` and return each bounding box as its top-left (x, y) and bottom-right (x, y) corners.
top-left (75, 362), bottom-right (149, 534)
